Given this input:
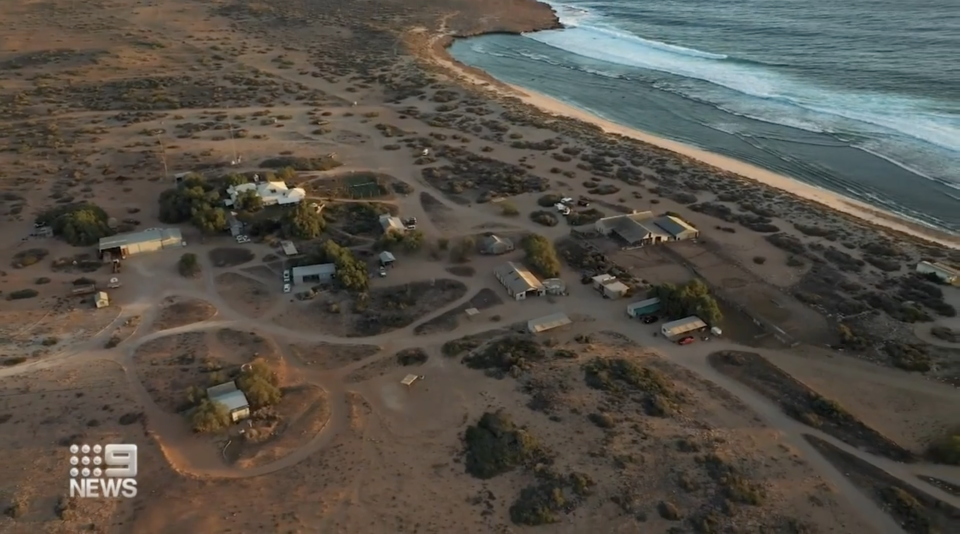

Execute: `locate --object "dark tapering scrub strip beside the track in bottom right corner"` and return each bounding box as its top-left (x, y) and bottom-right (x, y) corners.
top-left (804, 435), bottom-right (960, 534)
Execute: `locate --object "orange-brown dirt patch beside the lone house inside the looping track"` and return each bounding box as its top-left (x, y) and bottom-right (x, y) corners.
top-left (233, 386), bottom-right (330, 468)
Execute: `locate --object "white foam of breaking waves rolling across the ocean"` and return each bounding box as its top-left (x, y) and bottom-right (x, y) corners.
top-left (527, 3), bottom-right (960, 159)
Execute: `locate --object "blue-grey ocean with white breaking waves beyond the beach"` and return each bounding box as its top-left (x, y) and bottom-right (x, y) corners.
top-left (450, 0), bottom-right (960, 234)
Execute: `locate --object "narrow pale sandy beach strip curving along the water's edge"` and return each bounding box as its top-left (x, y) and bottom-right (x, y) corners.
top-left (427, 32), bottom-right (960, 249)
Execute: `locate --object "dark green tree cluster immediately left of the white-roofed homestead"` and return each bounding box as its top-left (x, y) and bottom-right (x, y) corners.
top-left (160, 174), bottom-right (227, 233)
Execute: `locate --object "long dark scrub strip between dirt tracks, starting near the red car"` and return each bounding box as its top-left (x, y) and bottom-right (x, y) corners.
top-left (708, 351), bottom-right (916, 462)
